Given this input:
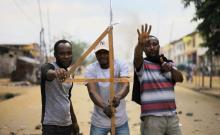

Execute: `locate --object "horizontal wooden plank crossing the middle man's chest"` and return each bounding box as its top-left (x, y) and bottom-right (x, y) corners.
top-left (65, 78), bottom-right (130, 83)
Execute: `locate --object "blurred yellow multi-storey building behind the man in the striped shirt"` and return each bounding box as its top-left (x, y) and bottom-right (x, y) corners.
top-left (161, 32), bottom-right (220, 75)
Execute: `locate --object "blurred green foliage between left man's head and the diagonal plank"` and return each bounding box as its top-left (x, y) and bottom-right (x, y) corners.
top-left (71, 41), bottom-right (87, 64)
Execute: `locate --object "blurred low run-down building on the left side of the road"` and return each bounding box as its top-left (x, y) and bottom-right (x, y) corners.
top-left (0, 43), bottom-right (40, 81)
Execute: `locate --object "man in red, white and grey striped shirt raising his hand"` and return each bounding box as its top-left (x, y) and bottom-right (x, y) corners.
top-left (132, 24), bottom-right (183, 135)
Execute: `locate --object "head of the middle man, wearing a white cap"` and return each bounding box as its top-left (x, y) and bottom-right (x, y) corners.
top-left (94, 42), bottom-right (109, 69)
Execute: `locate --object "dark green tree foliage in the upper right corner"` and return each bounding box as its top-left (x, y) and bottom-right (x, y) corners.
top-left (182, 0), bottom-right (220, 55)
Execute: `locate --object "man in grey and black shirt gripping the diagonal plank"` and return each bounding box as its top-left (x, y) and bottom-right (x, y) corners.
top-left (41, 40), bottom-right (79, 135)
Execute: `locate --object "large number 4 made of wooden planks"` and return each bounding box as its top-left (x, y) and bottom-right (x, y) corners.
top-left (66, 26), bottom-right (129, 135)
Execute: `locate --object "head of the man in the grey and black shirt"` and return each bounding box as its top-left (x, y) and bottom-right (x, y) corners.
top-left (54, 40), bottom-right (72, 68)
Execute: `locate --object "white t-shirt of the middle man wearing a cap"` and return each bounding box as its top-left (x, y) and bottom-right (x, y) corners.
top-left (85, 60), bottom-right (128, 128)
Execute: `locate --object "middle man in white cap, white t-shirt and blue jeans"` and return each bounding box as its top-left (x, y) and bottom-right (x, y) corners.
top-left (85, 42), bottom-right (129, 135)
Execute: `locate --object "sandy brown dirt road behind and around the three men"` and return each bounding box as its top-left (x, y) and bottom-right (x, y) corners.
top-left (0, 85), bottom-right (220, 135)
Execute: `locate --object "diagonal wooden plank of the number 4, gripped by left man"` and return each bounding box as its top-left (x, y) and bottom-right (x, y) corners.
top-left (67, 27), bottom-right (110, 77)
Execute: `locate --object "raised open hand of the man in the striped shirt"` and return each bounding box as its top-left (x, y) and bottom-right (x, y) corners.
top-left (137, 24), bottom-right (151, 44)
